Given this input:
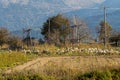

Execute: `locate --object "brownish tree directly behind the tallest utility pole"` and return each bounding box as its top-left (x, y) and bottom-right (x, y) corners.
top-left (98, 21), bottom-right (112, 43)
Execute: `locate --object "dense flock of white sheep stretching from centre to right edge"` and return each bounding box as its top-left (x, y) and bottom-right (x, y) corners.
top-left (56, 47), bottom-right (120, 54)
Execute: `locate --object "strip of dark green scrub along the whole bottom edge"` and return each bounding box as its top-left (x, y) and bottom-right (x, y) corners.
top-left (0, 69), bottom-right (120, 80)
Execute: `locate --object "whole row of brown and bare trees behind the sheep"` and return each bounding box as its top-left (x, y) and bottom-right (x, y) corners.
top-left (0, 14), bottom-right (120, 49)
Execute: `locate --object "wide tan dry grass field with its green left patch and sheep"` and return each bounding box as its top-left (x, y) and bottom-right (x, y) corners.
top-left (0, 45), bottom-right (120, 80)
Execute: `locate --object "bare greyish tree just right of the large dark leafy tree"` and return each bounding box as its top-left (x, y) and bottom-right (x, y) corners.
top-left (71, 16), bottom-right (90, 42)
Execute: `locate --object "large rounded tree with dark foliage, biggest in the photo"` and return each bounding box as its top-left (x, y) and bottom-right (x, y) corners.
top-left (41, 14), bottom-right (70, 43)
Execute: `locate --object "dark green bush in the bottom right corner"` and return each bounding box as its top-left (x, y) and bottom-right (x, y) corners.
top-left (77, 69), bottom-right (120, 80)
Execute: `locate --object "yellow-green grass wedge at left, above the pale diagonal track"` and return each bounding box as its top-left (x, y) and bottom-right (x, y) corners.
top-left (0, 50), bottom-right (37, 70)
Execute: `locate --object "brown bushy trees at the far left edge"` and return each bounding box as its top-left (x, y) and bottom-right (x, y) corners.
top-left (0, 27), bottom-right (22, 50)
